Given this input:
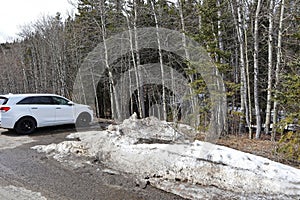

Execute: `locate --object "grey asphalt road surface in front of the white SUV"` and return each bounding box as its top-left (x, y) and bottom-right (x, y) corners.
top-left (0, 126), bottom-right (182, 200)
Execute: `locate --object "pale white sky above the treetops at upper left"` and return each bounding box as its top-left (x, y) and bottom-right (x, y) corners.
top-left (0, 0), bottom-right (76, 43)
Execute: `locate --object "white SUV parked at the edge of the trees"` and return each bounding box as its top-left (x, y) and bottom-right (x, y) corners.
top-left (0, 94), bottom-right (93, 134)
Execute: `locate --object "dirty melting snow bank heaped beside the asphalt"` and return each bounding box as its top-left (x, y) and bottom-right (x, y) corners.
top-left (33, 115), bottom-right (300, 199)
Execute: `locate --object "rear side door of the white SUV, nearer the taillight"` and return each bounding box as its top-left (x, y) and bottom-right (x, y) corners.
top-left (18, 96), bottom-right (55, 127)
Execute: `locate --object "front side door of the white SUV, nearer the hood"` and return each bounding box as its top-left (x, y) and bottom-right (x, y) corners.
top-left (52, 96), bottom-right (75, 124)
